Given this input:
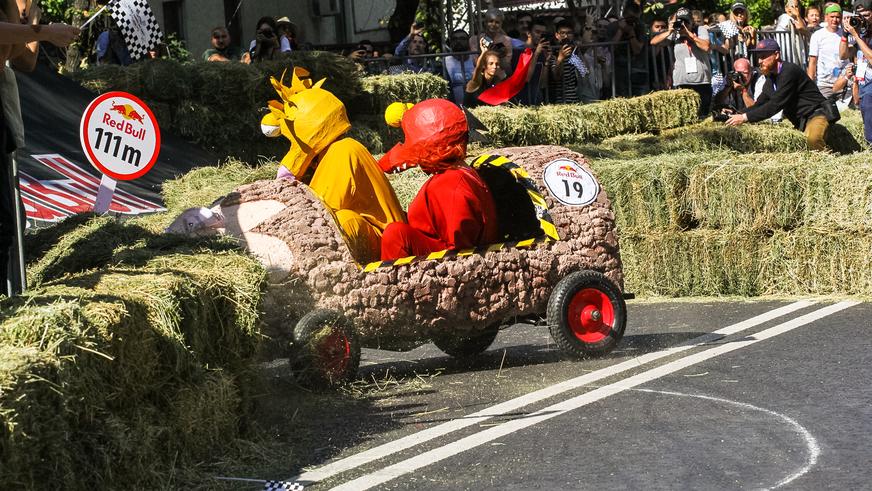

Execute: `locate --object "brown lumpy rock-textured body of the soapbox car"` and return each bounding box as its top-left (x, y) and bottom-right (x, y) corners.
top-left (221, 146), bottom-right (623, 347)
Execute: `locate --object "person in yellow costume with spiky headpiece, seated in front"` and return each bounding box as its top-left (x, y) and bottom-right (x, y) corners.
top-left (261, 67), bottom-right (405, 263)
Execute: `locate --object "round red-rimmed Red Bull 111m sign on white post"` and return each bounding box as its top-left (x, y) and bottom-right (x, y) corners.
top-left (79, 92), bottom-right (160, 213)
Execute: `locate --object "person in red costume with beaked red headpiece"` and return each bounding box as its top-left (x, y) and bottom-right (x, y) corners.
top-left (379, 99), bottom-right (498, 261)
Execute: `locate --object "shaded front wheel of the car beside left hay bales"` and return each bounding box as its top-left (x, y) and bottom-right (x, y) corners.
top-left (292, 309), bottom-right (360, 386)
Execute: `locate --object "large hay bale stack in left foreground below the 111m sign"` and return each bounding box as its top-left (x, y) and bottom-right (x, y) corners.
top-left (0, 216), bottom-right (265, 489)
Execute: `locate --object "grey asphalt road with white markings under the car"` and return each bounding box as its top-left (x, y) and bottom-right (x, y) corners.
top-left (240, 301), bottom-right (872, 490)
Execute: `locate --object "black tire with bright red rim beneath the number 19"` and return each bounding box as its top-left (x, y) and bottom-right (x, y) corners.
top-left (547, 271), bottom-right (627, 358)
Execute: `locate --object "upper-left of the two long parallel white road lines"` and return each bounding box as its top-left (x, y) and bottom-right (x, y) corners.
top-left (288, 300), bottom-right (815, 483)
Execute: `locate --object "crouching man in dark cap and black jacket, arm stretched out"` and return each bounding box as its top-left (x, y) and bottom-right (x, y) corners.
top-left (726, 39), bottom-right (829, 150)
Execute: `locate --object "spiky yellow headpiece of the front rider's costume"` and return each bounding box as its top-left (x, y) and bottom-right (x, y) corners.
top-left (261, 67), bottom-right (351, 178)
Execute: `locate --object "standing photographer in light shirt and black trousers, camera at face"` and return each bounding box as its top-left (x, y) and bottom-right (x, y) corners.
top-left (651, 7), bottom-right (712, 119)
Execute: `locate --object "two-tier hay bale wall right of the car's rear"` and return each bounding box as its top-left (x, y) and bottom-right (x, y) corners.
top-left (580, 112), bottom-right (872, 296)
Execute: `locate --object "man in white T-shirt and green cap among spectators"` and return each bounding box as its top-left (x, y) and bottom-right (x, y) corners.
top-left (808, 3), bottom-right (847, 97)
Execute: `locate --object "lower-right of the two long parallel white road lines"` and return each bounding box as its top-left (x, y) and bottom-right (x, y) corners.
top-left (332, 301), bottom-right (860, 491)
